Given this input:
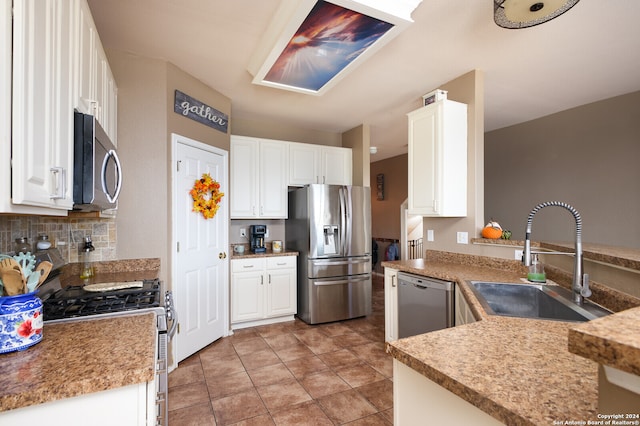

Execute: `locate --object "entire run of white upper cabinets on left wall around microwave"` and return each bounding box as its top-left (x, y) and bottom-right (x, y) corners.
top-left (0, 0), bottom-right (117, 216)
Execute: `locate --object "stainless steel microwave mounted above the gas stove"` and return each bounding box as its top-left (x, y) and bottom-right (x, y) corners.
top-left (73, 111), bottom-right (122, 211)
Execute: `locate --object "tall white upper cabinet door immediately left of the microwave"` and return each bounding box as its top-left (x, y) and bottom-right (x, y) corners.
top-left (8, 0), bottom-right (73, 215)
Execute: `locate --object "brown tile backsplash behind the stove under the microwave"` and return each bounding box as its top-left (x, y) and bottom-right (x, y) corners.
top-left (0, 216), bottom-right (116, 263)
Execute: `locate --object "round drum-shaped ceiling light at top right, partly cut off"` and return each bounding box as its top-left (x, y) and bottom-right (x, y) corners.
top-left (493, 0), bottom-right (580, 29)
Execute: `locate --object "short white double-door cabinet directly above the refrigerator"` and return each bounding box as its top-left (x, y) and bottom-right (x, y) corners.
top-left (289, 142), bottom-right (353, 186)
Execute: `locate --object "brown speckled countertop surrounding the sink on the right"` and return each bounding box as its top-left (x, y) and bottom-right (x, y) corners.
top-left (382, 252), bottom-right (640, 425)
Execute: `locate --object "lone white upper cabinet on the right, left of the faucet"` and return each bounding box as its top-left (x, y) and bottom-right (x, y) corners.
top-left (408, 99), bottom-right (467, 217)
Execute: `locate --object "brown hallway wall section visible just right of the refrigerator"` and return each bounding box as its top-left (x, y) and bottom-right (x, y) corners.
top-left (370, 154), bottom-right (408, 240)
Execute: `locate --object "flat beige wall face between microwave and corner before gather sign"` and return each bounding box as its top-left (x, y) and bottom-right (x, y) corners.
top-left (107, 51), bottom-right (169, 282)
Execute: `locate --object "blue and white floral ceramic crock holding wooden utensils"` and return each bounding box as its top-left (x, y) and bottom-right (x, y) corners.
top-left (0, 291), bottom-right (43, 353)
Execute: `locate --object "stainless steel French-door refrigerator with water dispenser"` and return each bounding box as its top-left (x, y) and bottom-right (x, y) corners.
top-left (285, 184), bottom-right (371, 324)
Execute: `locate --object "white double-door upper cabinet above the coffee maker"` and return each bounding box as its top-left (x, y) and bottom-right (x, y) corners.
top-left (229, 136), bottom-right (288, 219)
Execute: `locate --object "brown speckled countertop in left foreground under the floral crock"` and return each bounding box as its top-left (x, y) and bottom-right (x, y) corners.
top-left (0, 313), bottom-right (156, 412)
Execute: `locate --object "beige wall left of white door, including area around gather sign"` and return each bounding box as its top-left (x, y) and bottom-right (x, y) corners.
top-left (107, 51), bottom-right (231, 282)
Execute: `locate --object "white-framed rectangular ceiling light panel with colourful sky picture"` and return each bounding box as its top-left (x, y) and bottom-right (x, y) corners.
top-left (248, 0), bottom-right (422, 95)
